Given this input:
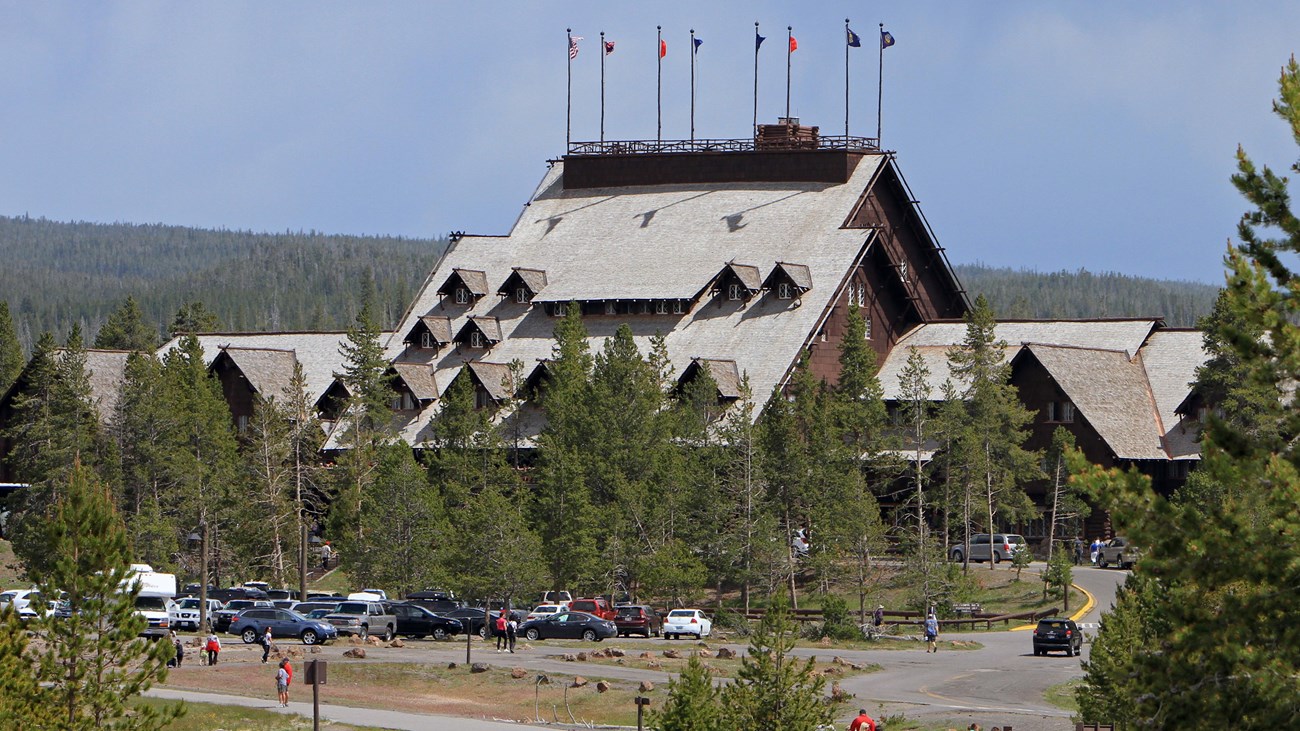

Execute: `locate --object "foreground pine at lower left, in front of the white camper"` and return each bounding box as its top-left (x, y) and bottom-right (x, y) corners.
top-left (27, 463), bottom-right (181, 731)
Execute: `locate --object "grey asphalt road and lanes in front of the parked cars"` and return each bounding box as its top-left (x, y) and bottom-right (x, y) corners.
top-left (150, 567), bottom-right (1127, 731)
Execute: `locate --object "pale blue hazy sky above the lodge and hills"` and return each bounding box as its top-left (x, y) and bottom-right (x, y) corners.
top-left (0, 0), bottom-right (1300, 282)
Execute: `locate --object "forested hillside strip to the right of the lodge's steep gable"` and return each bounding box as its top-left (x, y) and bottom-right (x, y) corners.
top-left (954, 264), bottom-right (1219, 328)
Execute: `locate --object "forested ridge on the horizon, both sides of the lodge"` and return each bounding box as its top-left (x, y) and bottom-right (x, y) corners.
top-left (0, 210), bottom-right (1218, 352)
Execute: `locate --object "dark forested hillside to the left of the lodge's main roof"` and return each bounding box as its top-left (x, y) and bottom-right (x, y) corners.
top-left (0, 212), bottom-right (446, 351)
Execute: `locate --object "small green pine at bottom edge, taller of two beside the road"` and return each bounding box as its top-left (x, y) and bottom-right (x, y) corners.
top-left (722, 594), bottom-right (833, 731)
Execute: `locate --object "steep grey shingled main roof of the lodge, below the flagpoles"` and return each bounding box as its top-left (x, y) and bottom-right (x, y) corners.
top-left (390, 155), bottom-right (891, 418)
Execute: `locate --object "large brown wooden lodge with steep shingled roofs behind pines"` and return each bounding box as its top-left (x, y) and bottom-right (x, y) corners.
top-left (0, 124), bottom-right (1205, 536)
